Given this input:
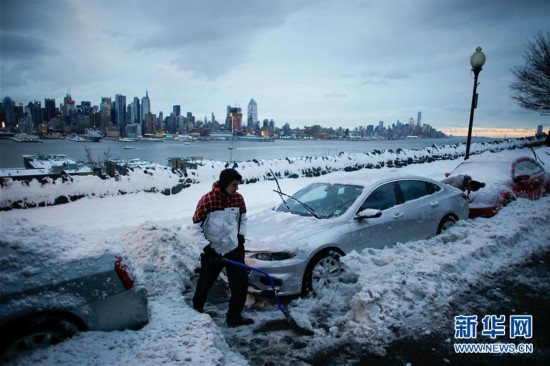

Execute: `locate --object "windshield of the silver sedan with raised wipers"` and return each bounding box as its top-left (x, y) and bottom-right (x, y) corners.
top-left (277, 183), bottom-right (363, 219)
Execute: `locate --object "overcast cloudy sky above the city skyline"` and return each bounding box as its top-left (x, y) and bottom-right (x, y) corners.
top-left (0, 0), bottom-right (550, 136)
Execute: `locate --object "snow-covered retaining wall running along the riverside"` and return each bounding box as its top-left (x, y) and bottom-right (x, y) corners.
top-left (0, 138), bottom-right (541, 210)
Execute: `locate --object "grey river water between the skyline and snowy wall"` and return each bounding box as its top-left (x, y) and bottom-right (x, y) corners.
top-left (0, 137), bottom-right (500, 168)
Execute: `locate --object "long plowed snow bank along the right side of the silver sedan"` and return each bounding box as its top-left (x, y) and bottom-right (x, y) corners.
top-left (343, 197), bottom-right (550, 346)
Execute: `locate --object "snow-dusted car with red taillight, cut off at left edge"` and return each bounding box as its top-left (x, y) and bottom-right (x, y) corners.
top-left (0, 233), bottom-right (149, 363)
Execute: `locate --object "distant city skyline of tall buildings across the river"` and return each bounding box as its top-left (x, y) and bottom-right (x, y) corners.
top-left (0, 90), bottom-right (448, 136)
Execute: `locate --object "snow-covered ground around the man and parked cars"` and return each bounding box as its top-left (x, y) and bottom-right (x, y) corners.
top-left (0, 148), bottom-right (550, 365)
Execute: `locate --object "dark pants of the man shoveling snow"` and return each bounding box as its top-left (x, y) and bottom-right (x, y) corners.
top-left (193, 245), bottom-right (248, 319)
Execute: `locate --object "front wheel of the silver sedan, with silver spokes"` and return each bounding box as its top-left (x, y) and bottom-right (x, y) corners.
top-left (302, 249), bottom-right (343, 294)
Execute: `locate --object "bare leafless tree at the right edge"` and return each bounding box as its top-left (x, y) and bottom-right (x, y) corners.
top-left (510, 31), bottom-right (550, 113)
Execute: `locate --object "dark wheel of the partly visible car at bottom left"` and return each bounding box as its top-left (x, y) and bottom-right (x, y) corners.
top-left (1, 315), bottom-right (79, 360)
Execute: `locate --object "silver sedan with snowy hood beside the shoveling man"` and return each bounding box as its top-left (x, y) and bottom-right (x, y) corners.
top-left (245, 173), bottom-right (468, 295)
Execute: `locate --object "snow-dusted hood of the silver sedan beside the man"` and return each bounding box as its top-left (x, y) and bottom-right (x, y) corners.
top-left (245, 210), bottom-right (339, 251)
